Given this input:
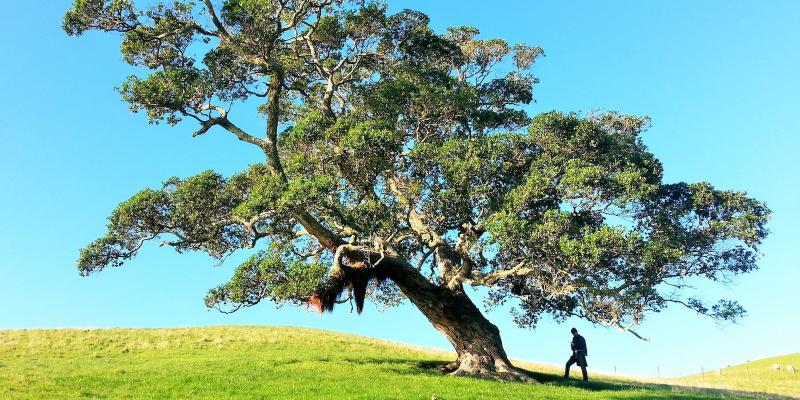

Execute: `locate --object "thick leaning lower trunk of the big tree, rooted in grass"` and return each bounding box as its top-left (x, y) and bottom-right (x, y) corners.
top-left (382, 256), bottom-right (535, 382)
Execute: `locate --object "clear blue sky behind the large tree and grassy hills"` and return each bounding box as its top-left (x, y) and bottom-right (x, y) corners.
top-left (0, 0), bottom-right (800, 375)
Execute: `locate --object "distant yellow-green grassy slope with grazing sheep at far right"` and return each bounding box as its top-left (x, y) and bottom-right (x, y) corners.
top-left (677, 353), bottom-right (800, 397)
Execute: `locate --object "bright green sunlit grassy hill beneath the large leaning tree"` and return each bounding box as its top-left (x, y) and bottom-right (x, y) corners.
top-left (0, 327), bottom-right (792, 400)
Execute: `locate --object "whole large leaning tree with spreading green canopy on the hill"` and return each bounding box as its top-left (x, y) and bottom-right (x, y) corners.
top-left (64, 0), bottom-right (769, 380)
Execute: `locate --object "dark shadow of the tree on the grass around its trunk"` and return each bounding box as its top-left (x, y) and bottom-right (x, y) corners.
top-left (412, 360), bottom-right (797, 400)
